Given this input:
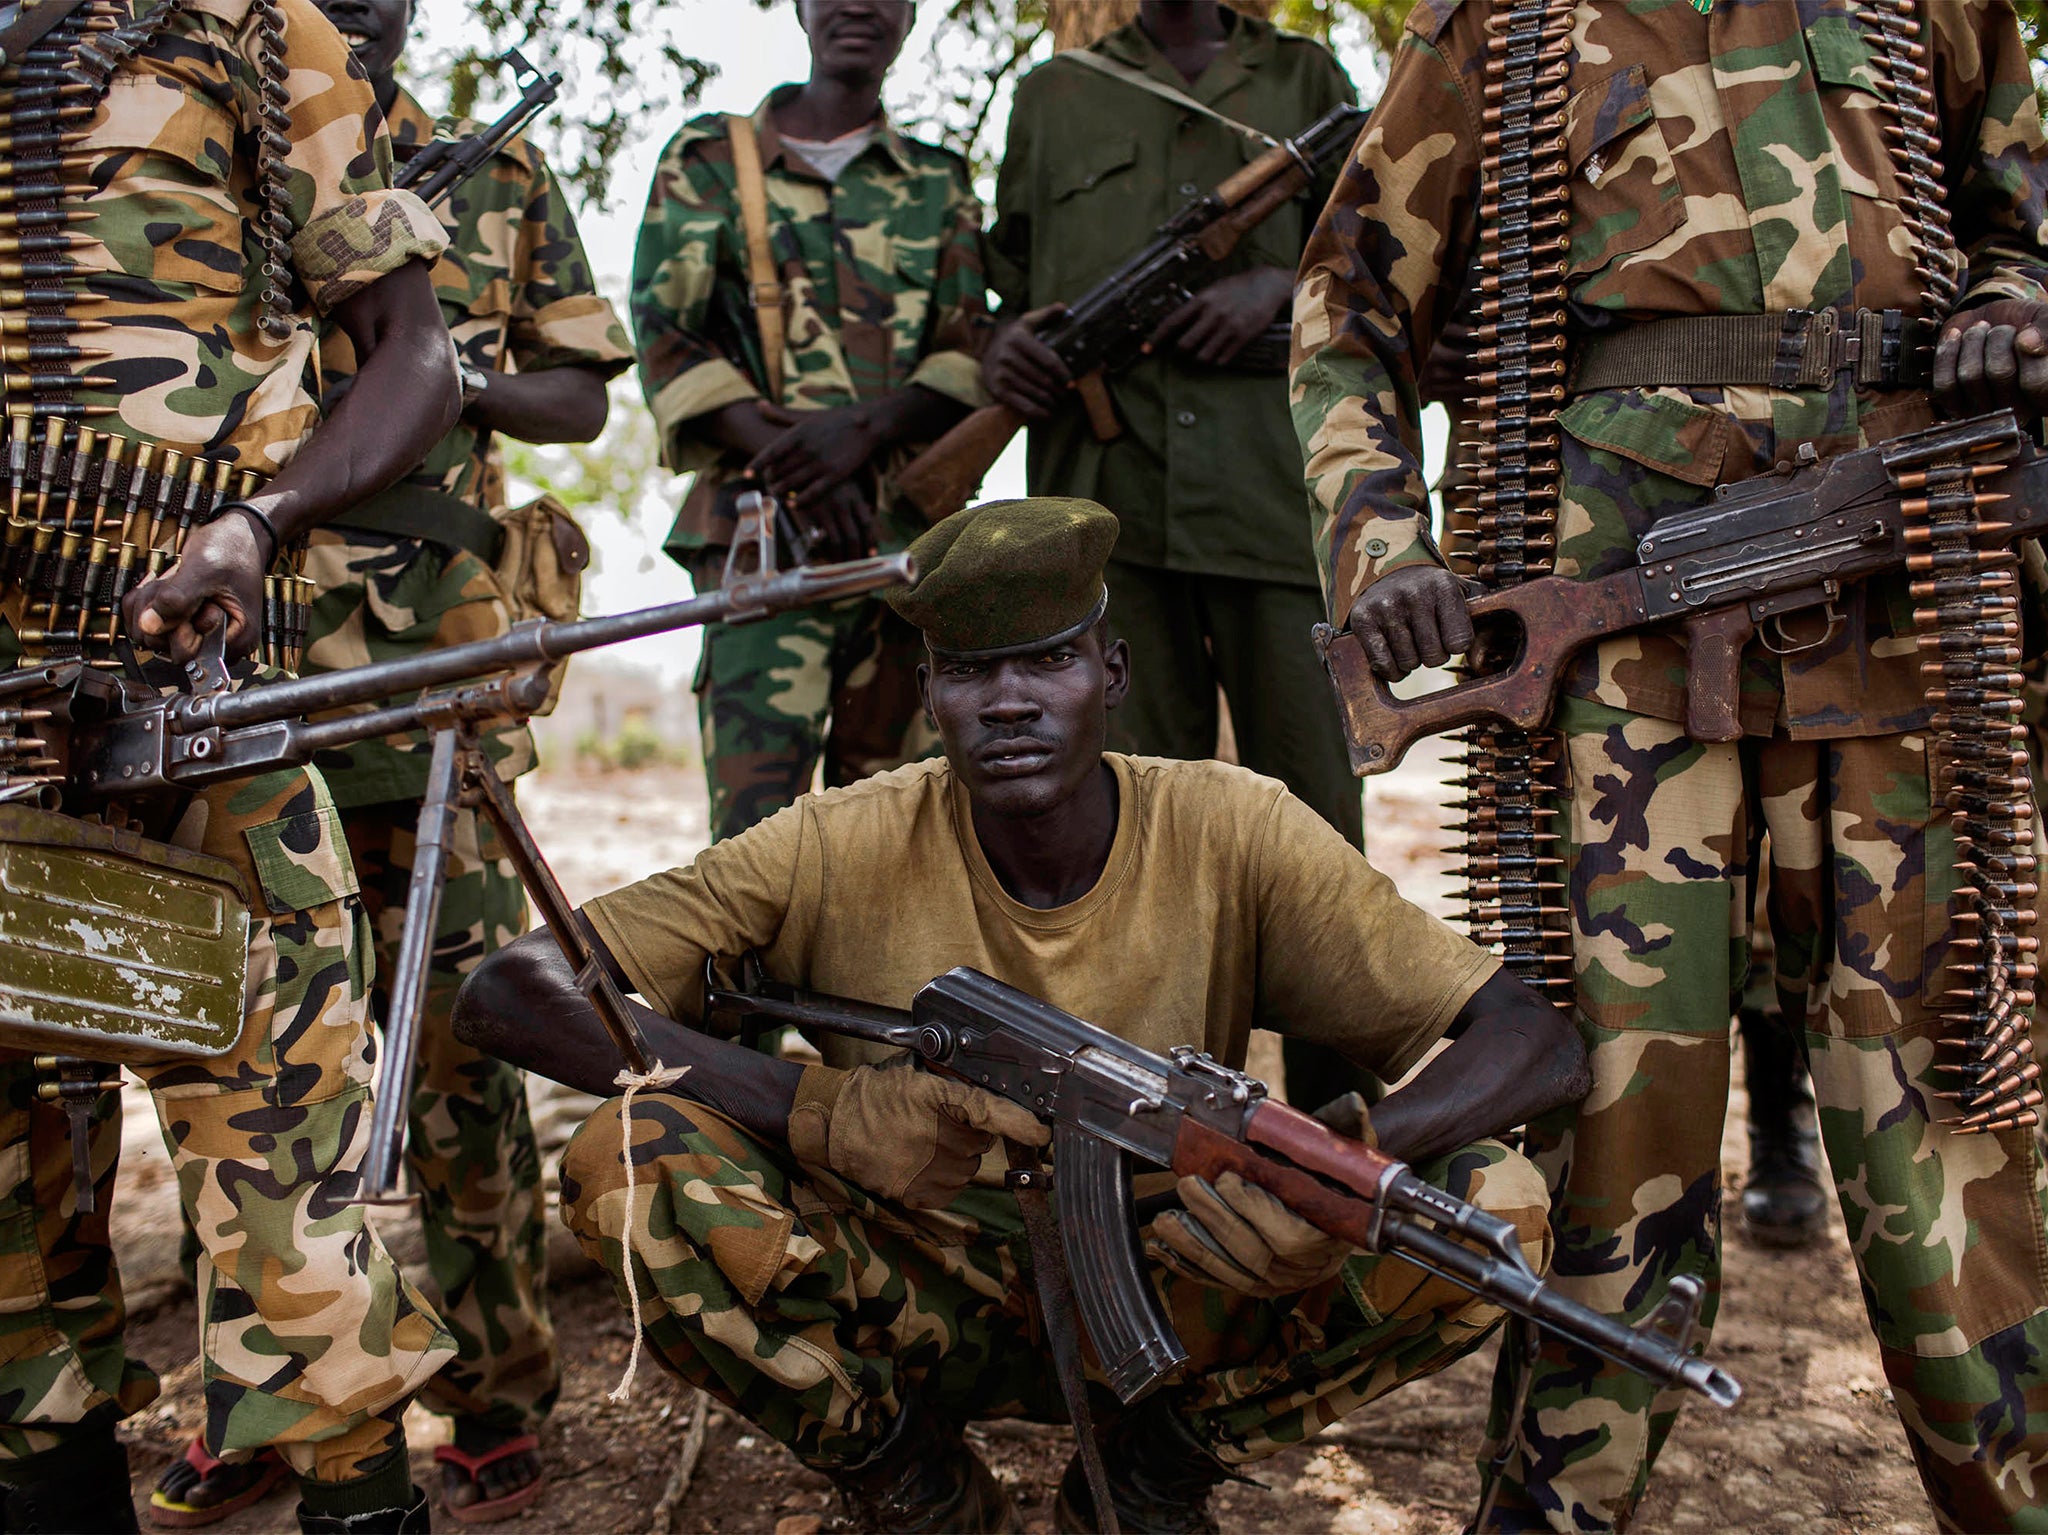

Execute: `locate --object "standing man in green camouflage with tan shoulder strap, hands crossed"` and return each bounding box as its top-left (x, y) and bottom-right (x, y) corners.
top-left (633, 0), bottom-right (987, 837)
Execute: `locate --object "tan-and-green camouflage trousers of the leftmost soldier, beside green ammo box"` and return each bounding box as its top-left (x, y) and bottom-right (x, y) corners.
top-left (0, 770), bottom-right (455, 1482)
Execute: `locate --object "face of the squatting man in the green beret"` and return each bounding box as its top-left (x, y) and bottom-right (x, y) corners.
top-left (918, 624), bottom-right (1130, 817)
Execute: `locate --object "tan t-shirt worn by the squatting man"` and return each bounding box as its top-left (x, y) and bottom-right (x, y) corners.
top-left (584, 753), bottom-right (1499, 1081)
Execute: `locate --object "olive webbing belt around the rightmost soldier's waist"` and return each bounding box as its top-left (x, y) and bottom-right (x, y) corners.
top-left (1569, 309), bottom-right (1935, 393)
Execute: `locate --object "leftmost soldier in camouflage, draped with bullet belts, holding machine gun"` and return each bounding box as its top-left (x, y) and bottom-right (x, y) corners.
top-left (0, 0), bottom-right (457, 1531)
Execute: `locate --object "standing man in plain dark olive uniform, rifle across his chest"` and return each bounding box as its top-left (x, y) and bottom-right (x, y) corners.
top-left (985, 0), bottom-right (1364, 1097)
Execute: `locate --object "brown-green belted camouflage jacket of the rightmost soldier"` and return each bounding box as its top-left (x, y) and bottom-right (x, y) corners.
top-left (1292, 0), bottom-right (2048, 737)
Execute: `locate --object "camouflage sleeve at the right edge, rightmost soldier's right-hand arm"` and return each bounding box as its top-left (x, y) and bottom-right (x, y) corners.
top-left (1925, 0), bottom-right (2048, 307)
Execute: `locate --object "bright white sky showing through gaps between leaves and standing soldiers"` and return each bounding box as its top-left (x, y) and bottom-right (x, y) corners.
top-left (414, 0), bottom-right (1442, 677)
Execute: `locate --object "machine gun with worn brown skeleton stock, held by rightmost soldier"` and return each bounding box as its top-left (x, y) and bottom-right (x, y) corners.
top-left (1315, 411), bottom-right (2048, 774)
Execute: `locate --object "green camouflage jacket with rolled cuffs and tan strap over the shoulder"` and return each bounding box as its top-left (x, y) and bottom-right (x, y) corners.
top-left (633, 86), bottom-right (987, 557)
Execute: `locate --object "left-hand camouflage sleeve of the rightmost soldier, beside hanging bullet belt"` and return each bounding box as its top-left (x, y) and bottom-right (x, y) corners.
top-left (1288, 6), bottom-right (1479, 622)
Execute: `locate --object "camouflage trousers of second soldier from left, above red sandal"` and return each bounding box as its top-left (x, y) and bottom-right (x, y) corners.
top-left (342, 802), bottom-right (561, 1431)
